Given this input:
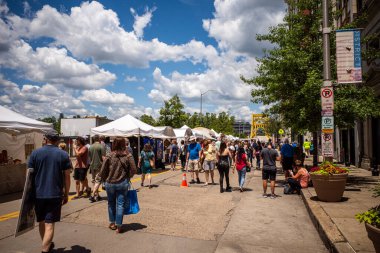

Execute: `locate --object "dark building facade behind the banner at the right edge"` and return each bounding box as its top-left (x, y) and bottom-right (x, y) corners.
top-left (333, 0), bottom-right (380, 169)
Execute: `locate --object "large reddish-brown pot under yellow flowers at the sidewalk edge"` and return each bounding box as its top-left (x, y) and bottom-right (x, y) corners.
top-left (311, 173), bottom-right (348, 202)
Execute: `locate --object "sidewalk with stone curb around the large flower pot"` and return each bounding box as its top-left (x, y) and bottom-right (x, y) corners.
top-left (302, 161), bottom-right (380, 253)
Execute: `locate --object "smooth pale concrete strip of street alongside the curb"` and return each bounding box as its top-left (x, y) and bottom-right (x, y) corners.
top-left (215, 170), bottom-right (328, 253)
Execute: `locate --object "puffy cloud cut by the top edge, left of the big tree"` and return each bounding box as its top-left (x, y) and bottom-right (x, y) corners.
top-left (203, 0), bottom-right (286, 55)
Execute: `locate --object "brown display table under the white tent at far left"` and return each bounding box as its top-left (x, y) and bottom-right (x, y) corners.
top-left (0, 163), bottom-right (26, 195)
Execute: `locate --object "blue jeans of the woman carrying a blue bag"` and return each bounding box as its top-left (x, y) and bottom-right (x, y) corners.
top-left (106, 179), bottom-right (129, 226)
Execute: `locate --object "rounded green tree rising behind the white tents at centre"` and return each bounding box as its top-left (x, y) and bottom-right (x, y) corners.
top-left (158, 95), bottom-right (187, 128)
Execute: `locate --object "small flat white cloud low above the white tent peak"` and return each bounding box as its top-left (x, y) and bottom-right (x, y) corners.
top-left (80, 89), bottom-right (134, 105)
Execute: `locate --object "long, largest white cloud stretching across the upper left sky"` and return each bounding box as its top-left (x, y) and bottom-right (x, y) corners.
top-left (0, 1), bottom-right (217, 67)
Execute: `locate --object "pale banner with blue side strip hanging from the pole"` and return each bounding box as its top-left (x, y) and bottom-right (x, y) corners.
top-left (336, 29), bottom-right (362, 83)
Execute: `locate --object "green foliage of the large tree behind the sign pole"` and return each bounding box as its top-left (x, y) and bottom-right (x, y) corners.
top-left (241, 0), bottom-right (380, 132)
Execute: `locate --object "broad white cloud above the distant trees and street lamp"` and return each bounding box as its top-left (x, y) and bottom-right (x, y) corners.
top-left (148, 54), bottom-right (257, 104)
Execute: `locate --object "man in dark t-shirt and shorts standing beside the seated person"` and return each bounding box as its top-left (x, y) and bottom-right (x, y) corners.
top-left (261, 143), bottom-right (280, 199)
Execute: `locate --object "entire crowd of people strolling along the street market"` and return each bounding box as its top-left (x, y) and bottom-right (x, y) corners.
top-left (28, 133), bottom-right (309, 252)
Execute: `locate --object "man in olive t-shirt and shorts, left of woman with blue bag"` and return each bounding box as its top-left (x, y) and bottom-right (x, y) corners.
top-left (89, 135), bottom-right (106, 202)
